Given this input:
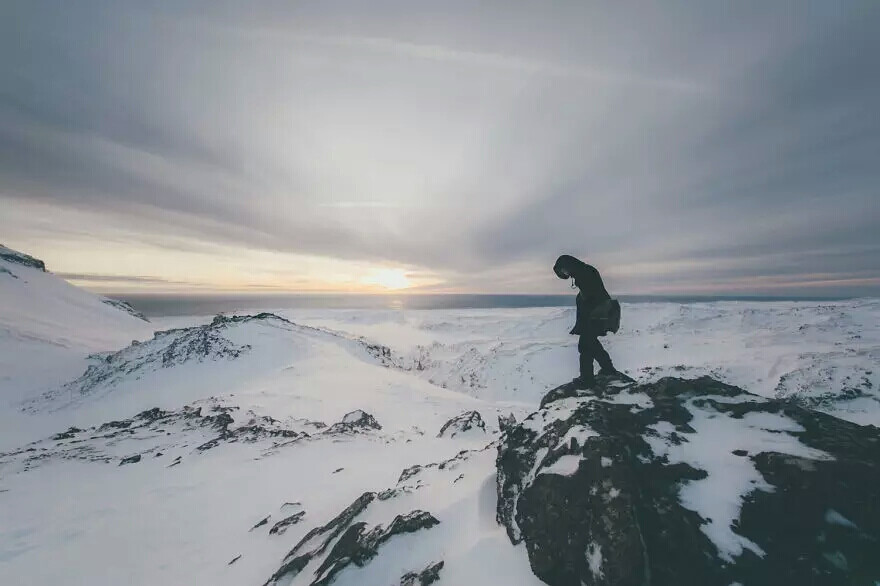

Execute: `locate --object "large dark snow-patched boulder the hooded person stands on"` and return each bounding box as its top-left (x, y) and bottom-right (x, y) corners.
top-left (497, 378), bottom-right (880, 586)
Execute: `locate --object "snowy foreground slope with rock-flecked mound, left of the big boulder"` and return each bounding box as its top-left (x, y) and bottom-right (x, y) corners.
top-left (0, 314), bottom-right (538, 584)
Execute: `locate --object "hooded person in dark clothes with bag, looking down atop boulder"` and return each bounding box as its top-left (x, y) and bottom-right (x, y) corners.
top-left (553, 254), bottom-right (620, 388)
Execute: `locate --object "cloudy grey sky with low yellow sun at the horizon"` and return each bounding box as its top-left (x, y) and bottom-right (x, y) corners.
top-left (0, 0), bottom-right (880, 295)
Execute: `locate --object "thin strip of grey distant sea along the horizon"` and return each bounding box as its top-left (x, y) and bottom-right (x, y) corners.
top-left (108, 293), bottom-right (842, 317)
